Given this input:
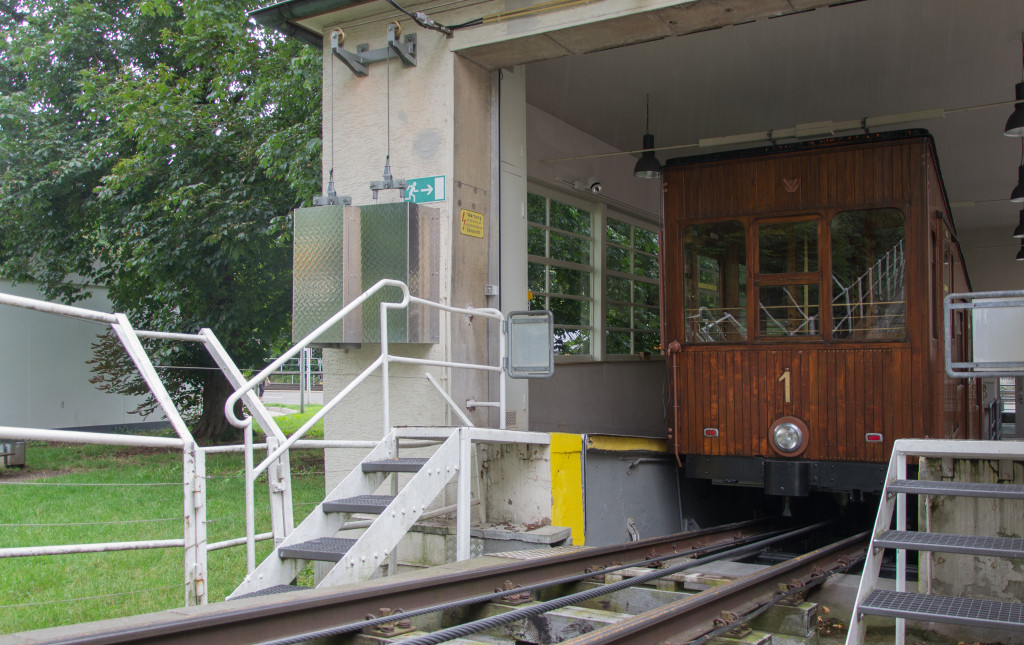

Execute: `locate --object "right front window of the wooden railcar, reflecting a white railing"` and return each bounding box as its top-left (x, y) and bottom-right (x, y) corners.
top-left (830, 208), bottom-right (906, 340)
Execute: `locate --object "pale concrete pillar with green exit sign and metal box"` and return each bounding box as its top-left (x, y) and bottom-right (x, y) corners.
top-left (323, 22), bottom-right (497, 489)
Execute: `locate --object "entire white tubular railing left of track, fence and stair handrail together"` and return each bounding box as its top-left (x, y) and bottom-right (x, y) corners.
top-left (0, 280), bottom-right (507, 605)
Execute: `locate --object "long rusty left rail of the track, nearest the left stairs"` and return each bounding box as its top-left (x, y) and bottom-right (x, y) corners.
top-left (19, 520), bottom-right (777, 645)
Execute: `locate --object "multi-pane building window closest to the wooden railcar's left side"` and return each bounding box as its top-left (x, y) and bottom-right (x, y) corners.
top-left (604, 217), bottom-right (660, 354)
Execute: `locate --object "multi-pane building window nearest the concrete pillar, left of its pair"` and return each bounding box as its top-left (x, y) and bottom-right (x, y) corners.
top-left (526, 194), bottom-right (594, 355)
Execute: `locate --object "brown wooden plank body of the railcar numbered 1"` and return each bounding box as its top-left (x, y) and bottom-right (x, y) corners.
top-left (662, 135), bottom-right (980, 462)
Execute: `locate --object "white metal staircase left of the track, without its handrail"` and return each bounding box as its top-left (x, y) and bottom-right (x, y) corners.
top-left (228, 427), bottom-right (549, 600)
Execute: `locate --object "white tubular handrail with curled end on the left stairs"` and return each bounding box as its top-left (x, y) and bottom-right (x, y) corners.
top-left (224, 280), bottom-right (507, 573)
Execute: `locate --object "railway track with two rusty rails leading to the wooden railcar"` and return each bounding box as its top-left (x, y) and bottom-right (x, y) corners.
top-left (23, 521), bottom-right (867, 645)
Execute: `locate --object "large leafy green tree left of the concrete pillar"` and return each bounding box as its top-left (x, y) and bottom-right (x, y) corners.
top-left (0, 0), bottom-right (321, 439)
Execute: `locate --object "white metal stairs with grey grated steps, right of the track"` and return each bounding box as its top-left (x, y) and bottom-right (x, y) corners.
top-left (846, 439), bottom-right (1024, 645)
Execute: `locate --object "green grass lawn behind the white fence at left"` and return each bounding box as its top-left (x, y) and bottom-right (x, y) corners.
top-left (0, 407), bottom-right (324, 634)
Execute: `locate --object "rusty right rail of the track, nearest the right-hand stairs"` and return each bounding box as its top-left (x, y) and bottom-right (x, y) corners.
top-left (563, 532), bottom-right (869, 645)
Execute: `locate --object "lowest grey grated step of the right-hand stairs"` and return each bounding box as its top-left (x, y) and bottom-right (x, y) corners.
top-left (859, 590), bottom-right (1024, 630)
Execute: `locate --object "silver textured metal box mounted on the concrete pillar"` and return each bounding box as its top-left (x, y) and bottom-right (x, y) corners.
top-left (292, 202), bottom-right (440, 346)
